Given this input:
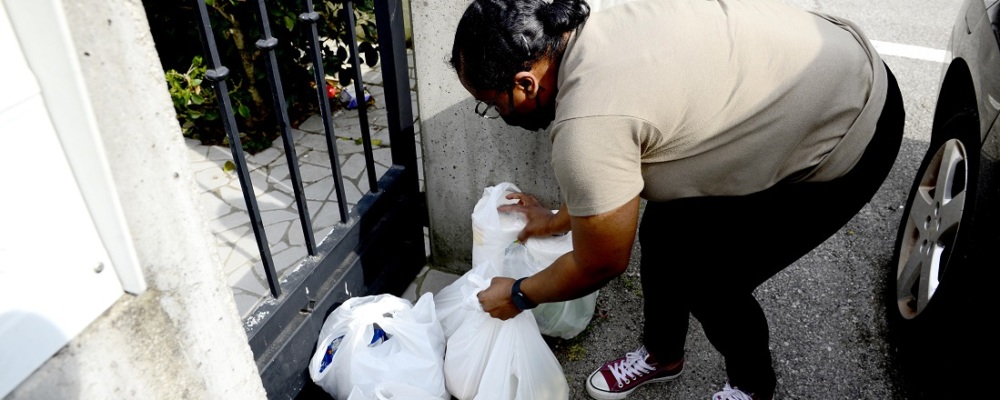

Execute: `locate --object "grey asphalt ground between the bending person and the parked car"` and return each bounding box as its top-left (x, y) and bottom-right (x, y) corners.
top-left (550, 0), bottom-right (972, 399)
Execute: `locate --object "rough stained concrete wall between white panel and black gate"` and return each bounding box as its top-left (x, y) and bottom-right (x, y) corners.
top-left (7, 0), bottom-right (266, 399)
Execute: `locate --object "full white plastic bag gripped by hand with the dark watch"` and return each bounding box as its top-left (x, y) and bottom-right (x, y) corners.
top-left (434, 260), bottom-right (569, 400)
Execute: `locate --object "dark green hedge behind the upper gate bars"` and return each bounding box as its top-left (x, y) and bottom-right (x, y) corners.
top-left (143, 0), bottom-right (378, 154)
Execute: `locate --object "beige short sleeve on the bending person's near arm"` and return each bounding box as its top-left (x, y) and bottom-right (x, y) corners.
top-left (552, 116), bottom-right (649, 216)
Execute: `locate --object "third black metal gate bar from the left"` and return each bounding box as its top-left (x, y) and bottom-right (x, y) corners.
top-left (299, 0), bottom-right (347, 222)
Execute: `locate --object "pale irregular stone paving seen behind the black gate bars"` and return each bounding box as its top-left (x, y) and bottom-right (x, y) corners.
top-left (187, 54), bottom-right (456, 319)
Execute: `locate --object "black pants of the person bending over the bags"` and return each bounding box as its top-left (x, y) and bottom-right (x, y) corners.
top-left (639, 66), bottom-right (904, 394)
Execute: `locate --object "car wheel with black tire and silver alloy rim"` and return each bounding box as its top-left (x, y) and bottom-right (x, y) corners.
top-left (886, 110), bottom-right (981, 398)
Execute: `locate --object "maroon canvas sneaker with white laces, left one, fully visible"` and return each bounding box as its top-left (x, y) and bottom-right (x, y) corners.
top-left (587, 346), bottom-right (684, 400)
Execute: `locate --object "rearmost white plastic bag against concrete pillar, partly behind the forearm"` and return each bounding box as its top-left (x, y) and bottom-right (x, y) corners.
top-left (472, 182), bottom-right (598, 339)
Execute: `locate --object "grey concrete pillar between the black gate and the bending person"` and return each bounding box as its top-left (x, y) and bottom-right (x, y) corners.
top-left (410, 0), bottom-right (559, 271)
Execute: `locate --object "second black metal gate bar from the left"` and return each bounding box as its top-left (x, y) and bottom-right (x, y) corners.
top-left (256, 0), bottom-right (316, 256)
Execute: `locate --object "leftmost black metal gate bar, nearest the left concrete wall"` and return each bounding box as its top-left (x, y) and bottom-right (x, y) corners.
top-left (197, 0), bottom-right (281, 298)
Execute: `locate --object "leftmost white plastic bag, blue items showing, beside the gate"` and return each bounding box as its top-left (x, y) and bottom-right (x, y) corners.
top-left (309, 293), bottom-right (450, 400)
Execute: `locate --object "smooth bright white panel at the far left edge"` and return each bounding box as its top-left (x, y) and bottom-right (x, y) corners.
top-left (0, 7), bottom-right (125, 396)
